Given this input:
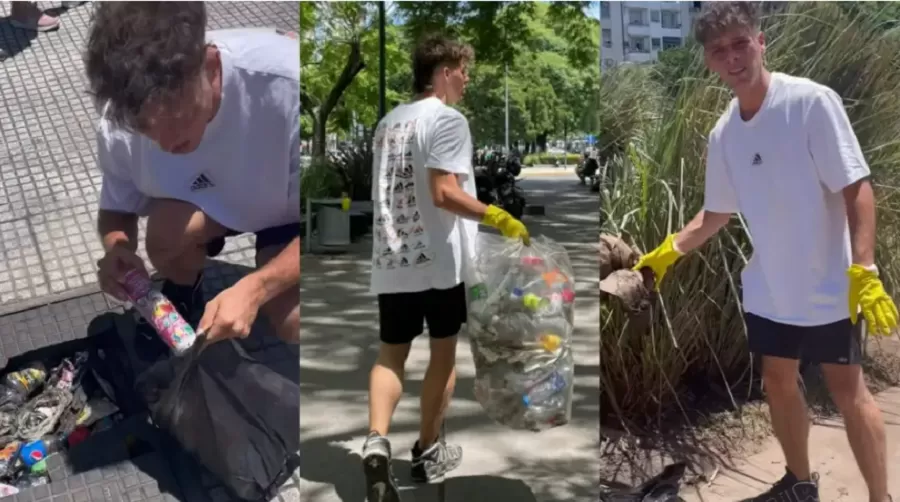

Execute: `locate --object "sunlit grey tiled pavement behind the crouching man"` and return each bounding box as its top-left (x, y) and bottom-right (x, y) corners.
top-left (0, 2), bottom-right (299, 312)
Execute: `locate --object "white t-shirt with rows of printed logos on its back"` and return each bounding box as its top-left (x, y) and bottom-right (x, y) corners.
top-left (371, 98), bottom-right (478, 294)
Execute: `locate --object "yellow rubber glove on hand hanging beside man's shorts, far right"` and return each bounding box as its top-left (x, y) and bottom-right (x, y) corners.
top-left (847, 264), bottom-right (897, 336)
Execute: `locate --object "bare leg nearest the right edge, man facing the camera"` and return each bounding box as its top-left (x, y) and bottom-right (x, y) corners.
top-left (822, 364), bottom-right (890, 502)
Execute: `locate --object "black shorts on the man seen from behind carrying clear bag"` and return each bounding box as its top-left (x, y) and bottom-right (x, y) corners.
top-left (378, 284), bottom-right (466, 345)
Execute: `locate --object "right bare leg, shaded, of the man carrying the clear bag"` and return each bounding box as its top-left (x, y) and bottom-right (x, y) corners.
top-left (419, 336), bottom-right (457, 450)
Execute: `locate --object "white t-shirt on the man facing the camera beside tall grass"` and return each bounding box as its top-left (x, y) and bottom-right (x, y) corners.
top-left (704, 73), bottom-right (869, 326)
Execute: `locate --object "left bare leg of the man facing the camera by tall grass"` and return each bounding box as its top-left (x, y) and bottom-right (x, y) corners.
top-left (763, 356), bottom-right (811, 481)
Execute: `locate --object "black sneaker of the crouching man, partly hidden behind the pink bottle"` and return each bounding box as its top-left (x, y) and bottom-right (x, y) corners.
top-left (134, 274), bottom-right (206, 362)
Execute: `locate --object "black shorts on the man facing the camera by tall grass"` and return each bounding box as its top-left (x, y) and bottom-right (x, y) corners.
top-left (744, 313), bottom-right (862, 364)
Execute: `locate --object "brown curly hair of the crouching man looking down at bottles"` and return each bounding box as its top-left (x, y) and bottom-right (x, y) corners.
top-left (84, 2), bottom-right (206, 129)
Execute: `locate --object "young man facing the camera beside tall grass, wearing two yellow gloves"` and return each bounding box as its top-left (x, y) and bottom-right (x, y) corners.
top-left (636, 2), bottom-right (897, 502)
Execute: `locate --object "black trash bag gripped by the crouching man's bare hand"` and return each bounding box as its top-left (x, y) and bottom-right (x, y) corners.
top-left (137, 339), bottom-right (300, 501)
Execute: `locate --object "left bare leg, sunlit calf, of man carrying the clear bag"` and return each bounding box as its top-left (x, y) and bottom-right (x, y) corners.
top-left (369, 342), bottom-right (411, 436)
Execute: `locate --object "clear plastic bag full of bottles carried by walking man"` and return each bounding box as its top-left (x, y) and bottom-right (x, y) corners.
top-left (466, 233), bottom-right (575, 431)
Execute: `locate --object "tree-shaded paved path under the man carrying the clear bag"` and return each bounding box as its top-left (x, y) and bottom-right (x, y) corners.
top-left (300, 175), bottom-right (600, 502)
